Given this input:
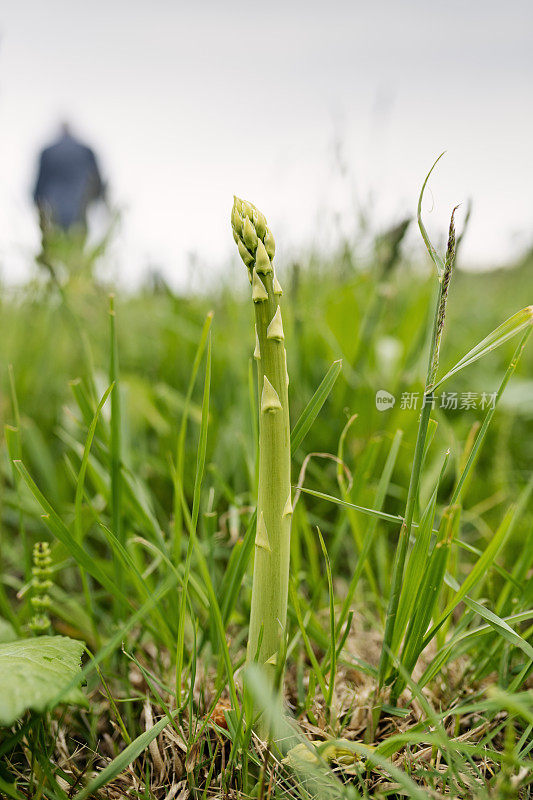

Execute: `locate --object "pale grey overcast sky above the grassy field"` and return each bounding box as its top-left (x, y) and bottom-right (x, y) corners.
top-left (0, 0), bottom-right (533, 284)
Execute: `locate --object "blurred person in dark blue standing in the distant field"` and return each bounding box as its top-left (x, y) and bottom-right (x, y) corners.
top-left (33, 123), bottom-right (105, 267)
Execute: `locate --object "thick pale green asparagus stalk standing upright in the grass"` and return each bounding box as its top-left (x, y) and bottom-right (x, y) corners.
top-left (231, 197), bottom-right (292, 681)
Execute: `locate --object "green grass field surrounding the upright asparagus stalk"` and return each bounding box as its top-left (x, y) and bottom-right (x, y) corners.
top-left (0, 195), bottom-right (533, 800)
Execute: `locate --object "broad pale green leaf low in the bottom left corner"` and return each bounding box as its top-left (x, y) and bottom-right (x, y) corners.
top-left (0, 636), bottom-right (85, 726)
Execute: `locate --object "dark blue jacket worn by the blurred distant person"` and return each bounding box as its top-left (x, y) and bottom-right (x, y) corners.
top-left (33, 133), bottom-right (104, 230)
